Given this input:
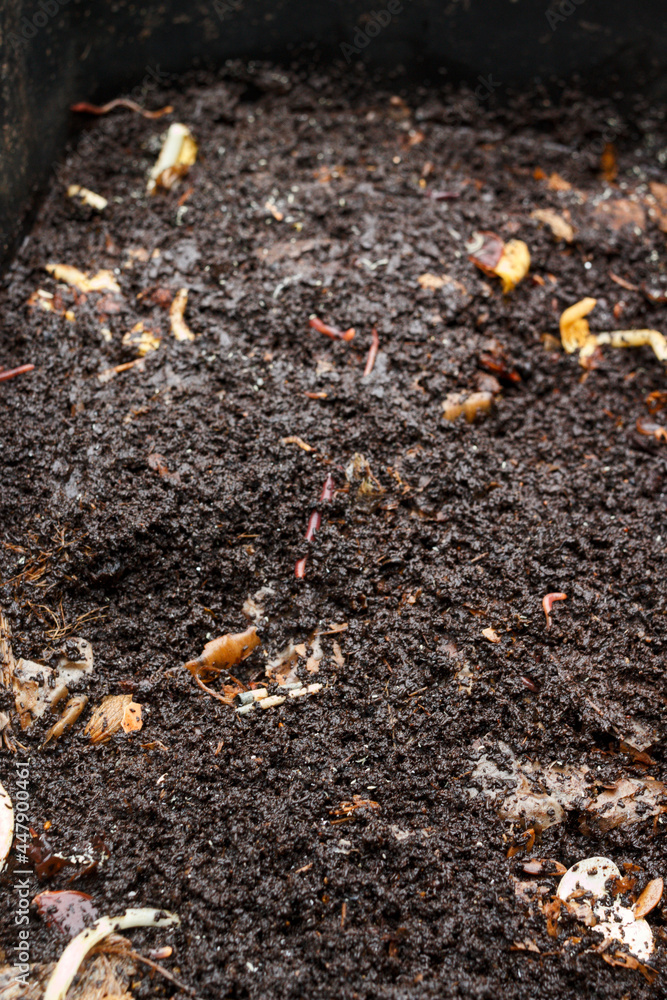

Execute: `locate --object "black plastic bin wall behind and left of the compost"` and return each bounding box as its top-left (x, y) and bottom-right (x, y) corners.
top-left (0, 0), bottom-right (667, 263)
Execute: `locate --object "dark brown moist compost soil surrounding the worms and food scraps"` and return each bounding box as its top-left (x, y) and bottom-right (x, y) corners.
top-left (0, 65), bottom-right (667, 1000)
